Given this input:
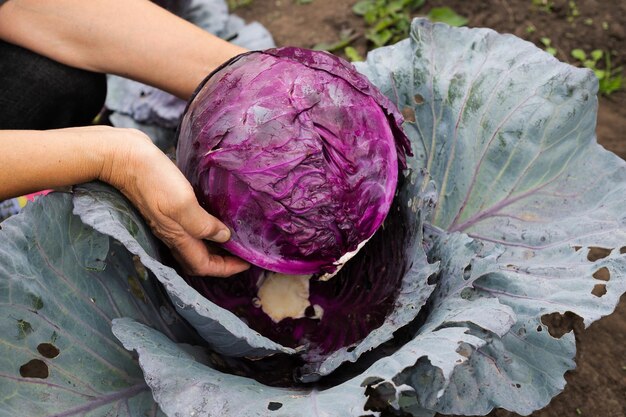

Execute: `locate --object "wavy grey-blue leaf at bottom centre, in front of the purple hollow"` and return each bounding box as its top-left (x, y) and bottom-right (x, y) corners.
top-left (113, 319), bottom-right (484, 417)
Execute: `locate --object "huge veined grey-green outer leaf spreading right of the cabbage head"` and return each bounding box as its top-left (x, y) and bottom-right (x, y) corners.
top-left (357, 20), bottom-right (626, 414)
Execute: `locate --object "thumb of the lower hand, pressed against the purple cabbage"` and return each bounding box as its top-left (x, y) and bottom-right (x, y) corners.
top-left (174, 199), bottom-right (230, 243)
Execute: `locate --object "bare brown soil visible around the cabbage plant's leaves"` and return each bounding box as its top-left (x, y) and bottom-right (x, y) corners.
top-left (235, 0), bottom-right (626, 417)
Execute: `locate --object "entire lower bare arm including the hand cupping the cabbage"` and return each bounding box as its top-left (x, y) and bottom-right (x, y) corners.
top-left (0, 126), bottom-right (248, 276)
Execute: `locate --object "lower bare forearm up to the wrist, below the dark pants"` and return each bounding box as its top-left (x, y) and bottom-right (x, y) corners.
top-left (0, 127), bottom-right (134, 200)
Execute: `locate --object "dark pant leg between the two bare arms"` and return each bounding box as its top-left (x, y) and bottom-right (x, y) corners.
top-left (0, 41), bottom-right (106, 129)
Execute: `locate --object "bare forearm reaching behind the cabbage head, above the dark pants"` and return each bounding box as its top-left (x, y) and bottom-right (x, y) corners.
top-left (0, 0), bottom-right (244, 99)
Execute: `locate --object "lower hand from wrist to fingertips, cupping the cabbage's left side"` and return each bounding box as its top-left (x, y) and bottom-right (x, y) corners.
top-left (100, 128), bottom-right (249, 277)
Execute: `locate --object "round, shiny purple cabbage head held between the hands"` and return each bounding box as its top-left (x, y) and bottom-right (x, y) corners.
top-left (177, 47), bottom-right (410, 274)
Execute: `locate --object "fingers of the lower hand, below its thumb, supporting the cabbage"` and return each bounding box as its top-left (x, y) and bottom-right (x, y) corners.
top-left (171, 232), bottom-right (250, 278)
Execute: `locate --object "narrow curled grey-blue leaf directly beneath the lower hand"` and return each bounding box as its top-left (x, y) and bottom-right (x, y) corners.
top-left (74, 183), bottom-right (294, 357)
